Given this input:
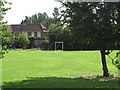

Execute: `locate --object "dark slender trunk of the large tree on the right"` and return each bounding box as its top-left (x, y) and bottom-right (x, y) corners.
top-left (100, 49), bottom-right (109, 77)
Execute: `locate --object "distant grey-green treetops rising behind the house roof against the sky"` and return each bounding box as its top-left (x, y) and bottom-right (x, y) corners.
top-left (21, 8), bottom-right (59, 28)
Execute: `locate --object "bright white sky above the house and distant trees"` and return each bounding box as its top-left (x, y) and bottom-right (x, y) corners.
top-left (4, 0), bottom-right (61, 24)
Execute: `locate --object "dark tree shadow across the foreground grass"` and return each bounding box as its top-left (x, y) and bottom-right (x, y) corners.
top-left (3, 77), bottom-right (118, 88)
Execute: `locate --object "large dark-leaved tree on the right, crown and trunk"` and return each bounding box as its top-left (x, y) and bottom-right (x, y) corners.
top-left (61, 2), bottom-right (120, 77)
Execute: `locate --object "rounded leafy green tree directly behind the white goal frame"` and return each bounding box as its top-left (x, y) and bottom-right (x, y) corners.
top-left (49, 23), bottom-right (73, 50)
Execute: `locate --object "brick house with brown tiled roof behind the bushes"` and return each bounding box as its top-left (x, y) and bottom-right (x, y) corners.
top-left (8, 24), bottom-right (49, 47)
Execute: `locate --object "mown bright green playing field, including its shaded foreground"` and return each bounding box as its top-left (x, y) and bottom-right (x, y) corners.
top-left (2, 51), bottom-right (118, 88)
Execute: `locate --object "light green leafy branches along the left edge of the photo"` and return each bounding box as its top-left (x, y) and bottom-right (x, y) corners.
top-left (0, 0), bottom-right (12, 58)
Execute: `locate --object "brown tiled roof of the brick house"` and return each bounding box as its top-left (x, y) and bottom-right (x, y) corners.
top-left (8, 24), bottom-right (48, 32)
